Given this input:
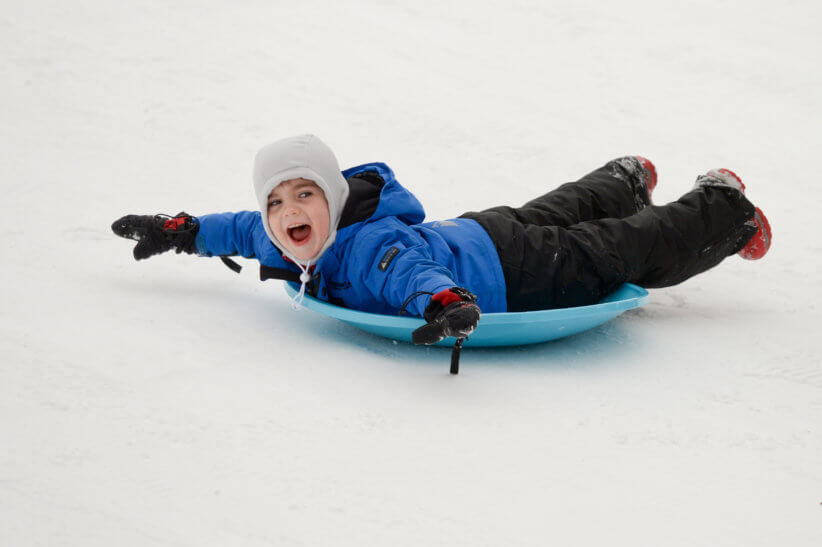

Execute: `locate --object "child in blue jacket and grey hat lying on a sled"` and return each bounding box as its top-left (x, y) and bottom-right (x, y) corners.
top-left (112, 135), bottom-right (771, 344)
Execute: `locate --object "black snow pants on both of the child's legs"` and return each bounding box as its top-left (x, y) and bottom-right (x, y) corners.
top-left (462, 157), bottom-right (756, 311)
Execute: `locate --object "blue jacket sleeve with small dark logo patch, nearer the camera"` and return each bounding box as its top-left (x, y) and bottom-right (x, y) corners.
top-left (348, 218), bottom-right (456, 317)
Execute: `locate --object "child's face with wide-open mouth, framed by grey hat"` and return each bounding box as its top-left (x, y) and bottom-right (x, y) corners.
top-left (268, 179), bottom-right (330, 260)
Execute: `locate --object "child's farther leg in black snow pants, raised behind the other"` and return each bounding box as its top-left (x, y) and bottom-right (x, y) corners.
top-left (469, 156), bottom-right (656, 227)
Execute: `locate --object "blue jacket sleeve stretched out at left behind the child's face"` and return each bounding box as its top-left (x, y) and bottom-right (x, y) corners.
top-left (195, 211), bottom-right (268, 258)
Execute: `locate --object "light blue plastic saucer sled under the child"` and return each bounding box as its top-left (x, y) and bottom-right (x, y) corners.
top-left (285, 283), bottom-right (648, 347)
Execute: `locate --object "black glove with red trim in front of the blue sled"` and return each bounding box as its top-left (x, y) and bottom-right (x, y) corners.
top-left (411, 287), bottom-right (480, 345)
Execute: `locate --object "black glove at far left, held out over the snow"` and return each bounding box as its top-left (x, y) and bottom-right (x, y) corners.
top-left (111, 213), bottom-right (200, 260)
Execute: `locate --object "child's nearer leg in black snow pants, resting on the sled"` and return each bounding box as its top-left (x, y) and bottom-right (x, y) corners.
top-left (478, 187), bottom-right (756, 311)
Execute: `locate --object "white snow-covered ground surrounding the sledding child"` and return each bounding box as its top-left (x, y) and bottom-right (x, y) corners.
top-left (0, 0), bottom-right (822, 547)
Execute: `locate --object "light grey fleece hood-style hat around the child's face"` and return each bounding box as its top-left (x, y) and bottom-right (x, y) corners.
top-left (254, 134), bottom-right (349, 263)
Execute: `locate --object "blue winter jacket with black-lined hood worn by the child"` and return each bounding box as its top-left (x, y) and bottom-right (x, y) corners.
top-left (196, 163), bottom-right (506, 316)
